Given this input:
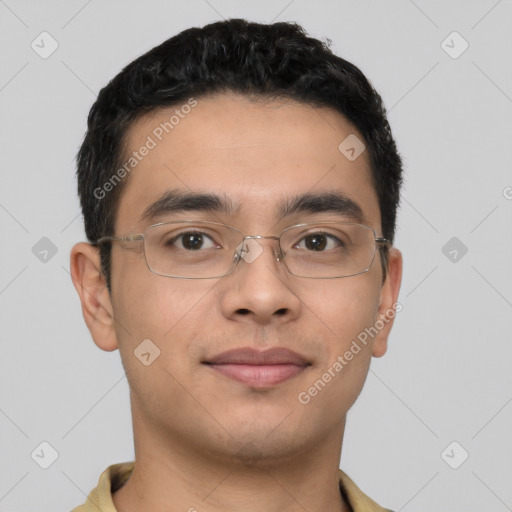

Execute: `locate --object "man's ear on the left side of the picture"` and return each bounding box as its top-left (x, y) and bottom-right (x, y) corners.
top-left (69, 242), bottom-right (118, 351)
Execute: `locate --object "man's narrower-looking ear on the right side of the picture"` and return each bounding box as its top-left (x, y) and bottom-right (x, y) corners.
top-left (372, 247), bottom-right (402, 357)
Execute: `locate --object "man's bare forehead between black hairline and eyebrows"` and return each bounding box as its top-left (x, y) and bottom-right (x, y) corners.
top-left (116, 94), bottom-right (380, 232)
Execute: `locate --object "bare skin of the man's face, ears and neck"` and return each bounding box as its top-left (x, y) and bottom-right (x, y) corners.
top-left (71, 93), bottom-right (402, 512)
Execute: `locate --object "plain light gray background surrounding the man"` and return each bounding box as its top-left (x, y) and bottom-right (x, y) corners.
top-left (0, 0), bottom-right (512, 512)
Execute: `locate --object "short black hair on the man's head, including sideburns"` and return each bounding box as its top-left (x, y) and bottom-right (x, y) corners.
top-left (77, 19), bottom-right (403, 292)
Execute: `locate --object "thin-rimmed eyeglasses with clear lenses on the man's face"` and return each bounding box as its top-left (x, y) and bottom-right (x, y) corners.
top-left (95, 220), bottom-right (390, 279)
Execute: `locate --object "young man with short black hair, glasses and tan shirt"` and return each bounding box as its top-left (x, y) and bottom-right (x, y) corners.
top-left (71, 19), bottom-right (402, 512)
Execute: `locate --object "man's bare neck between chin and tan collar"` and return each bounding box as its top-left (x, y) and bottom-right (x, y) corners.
top-left (113, 412), bottom-right (351, 512)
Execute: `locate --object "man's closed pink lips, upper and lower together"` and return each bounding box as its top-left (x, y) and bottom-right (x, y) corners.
top-left (203, 347), bottom-right (311, 389)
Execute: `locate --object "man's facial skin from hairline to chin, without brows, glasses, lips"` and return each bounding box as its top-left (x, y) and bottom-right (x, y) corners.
top-left (96, 95), bottom-right (398, 464)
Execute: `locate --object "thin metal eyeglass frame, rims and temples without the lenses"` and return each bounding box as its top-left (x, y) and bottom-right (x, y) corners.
top-left (91, 219), bottom-right (391, 279)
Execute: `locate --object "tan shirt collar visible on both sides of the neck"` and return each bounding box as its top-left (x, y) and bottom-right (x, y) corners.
top-left (71, 462), bottom-right (392, 512)
